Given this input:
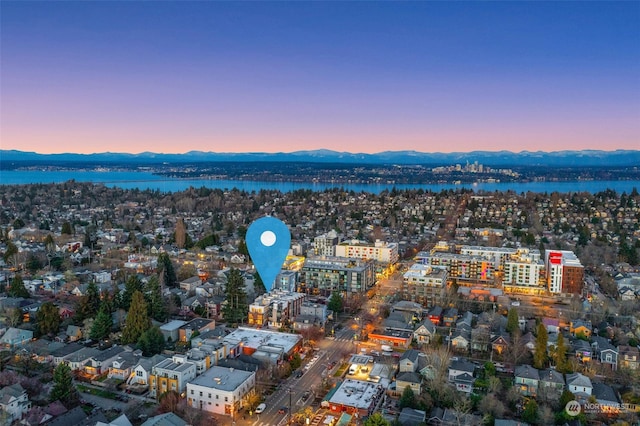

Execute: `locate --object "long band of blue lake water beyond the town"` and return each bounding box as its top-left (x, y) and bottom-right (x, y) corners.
top-left (0, 170), bottom-right (640, 194)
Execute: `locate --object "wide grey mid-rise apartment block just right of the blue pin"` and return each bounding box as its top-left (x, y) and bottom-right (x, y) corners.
top-left (298, 257), bottom-right (376, 296)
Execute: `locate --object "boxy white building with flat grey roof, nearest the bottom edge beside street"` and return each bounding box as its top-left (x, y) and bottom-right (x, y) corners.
top-left (186, 366), bottom-right (256, 417)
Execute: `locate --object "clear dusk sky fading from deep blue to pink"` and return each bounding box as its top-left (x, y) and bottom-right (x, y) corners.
top-left (0, 0), bottom-right (640, 153)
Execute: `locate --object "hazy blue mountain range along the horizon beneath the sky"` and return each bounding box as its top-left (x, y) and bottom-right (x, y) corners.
top-left (0, 149), bottom-right (640, 168)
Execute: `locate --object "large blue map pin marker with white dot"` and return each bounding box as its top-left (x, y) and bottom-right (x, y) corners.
top-left (245, 216), bottom-right (291, 292)
